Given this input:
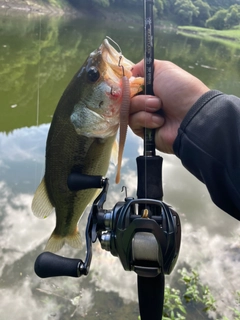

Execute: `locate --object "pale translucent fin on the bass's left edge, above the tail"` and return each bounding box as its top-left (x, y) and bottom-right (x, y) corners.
top-left (32, 178), bottom-right (53, 219)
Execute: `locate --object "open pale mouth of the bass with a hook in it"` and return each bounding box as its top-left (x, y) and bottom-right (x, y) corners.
top-left (101, 38), bottom-right (134, 78)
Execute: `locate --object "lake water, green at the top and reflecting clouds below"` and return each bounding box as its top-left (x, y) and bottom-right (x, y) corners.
top-left (0, 10), bottom-right (240, 320)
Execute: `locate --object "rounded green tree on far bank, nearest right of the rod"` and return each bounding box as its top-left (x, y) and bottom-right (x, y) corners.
top-left (175, 0), bottom-right (199, 24)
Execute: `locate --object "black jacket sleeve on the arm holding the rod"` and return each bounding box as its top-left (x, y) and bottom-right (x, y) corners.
top-left (173, 90), bottom-right (240, 220)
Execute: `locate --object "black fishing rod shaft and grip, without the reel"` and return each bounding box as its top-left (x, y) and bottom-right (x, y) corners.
top-left (136, 0), bottom-right (165, 320)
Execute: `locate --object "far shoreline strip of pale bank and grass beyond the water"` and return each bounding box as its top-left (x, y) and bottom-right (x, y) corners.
top-left (0, 0), bottom-right (240, 43)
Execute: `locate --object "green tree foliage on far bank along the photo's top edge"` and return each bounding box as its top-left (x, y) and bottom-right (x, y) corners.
top-left (63, 0), bottom-right (240, 30)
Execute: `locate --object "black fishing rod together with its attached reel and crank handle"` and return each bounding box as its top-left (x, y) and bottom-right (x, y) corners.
top-left (34, 0), bottom-right (181, 320)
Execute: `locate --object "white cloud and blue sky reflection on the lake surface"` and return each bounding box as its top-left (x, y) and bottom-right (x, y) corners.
top-left (0, 125), bottom-right (240, 320)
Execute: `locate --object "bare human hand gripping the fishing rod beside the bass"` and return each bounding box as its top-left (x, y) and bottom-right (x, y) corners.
top-left (129, 60), bottom-right (210, 153)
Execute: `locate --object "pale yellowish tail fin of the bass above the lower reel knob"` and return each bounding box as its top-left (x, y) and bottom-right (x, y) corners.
top-left (44, 229), bottom-right (82, 253)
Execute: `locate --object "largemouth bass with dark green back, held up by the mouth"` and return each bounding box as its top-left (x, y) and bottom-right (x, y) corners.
top-left (32, 39), bottom-right (144, 252)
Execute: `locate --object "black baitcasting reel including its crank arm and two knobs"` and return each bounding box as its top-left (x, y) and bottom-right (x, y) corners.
top-left (35, 173), bottom-right (181, 278)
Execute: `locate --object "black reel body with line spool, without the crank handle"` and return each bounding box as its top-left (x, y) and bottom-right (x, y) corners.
top-left (100, 198), bottom-right (181, 277)
